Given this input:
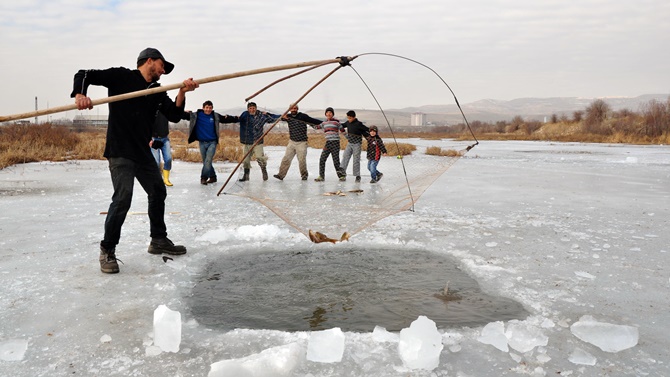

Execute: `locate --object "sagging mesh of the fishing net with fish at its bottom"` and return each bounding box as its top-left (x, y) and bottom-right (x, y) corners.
top-left (222, 135), bottom-right (467, 242)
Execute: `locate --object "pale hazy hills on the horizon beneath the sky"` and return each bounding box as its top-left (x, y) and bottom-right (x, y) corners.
top-left (223, 94), bottom-right (670, 126)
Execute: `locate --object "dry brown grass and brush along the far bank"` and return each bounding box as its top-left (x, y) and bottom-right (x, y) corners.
top-left (0, 122), bottom-right (670, 169)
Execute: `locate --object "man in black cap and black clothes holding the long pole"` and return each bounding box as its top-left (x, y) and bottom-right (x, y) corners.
top-left (70, 48), bottom-right (198, 273)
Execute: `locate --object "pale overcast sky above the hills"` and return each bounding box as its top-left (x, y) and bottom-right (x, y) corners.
top-left (0, 0), bottom-right (670, 119)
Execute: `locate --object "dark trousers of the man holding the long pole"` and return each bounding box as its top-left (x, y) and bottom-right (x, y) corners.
top-left (100, 157), bottom-right (167, 250)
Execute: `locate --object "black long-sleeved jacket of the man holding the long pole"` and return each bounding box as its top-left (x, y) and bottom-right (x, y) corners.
top-left (70, 67), bottom-right (184, 162)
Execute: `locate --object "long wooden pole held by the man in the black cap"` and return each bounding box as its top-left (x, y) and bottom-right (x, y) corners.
top-left (0, 58), bottom-right (351, 122)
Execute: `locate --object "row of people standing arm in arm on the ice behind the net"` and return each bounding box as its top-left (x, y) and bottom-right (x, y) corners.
top-left (186, 101), bottom-right (386, 185)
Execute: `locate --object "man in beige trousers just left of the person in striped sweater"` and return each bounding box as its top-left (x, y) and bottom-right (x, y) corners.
top-left (274, 104), bottom-right (321, 181)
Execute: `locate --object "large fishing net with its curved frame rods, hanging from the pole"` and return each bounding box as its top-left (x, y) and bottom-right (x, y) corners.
top-left (219, 54), bottom-right (477, 242)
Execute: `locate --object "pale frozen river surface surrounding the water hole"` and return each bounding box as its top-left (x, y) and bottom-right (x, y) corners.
top-left (0, 141), bottom-right (670, 377)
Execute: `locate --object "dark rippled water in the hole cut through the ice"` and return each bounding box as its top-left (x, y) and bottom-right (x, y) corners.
top-left (189, 248), bottom-right (528, 332)
